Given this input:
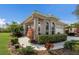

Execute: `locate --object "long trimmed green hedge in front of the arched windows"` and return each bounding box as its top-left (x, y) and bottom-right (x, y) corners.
top-left (38, 34), bottom-right (67, 44)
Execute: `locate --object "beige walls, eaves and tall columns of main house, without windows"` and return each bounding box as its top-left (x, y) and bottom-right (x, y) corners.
top-left (23, 15), bottom-right (64, 39)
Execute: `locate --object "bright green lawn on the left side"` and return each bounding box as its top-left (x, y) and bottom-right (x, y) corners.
top-left (0, 33), bottom-right (10, 55)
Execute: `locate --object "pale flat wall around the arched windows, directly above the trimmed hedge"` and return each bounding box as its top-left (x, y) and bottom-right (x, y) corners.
top-left (36, 20), bottom-right (64, 34)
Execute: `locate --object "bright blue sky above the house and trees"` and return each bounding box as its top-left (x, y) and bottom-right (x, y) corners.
top-left (0, 4), bottom-right (77, 27)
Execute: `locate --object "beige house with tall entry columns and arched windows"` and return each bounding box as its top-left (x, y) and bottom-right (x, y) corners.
top-left (22, 11), bottom-right (66, 39)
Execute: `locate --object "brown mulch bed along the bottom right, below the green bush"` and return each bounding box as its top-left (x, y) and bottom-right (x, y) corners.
top-left (49, 48), bottom-right (79, 55)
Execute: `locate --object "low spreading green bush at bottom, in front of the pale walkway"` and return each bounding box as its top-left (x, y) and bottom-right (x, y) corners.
top-left (19, 46), bottom-right (34, 55)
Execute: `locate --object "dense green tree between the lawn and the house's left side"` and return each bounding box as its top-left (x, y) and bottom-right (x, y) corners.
top-left (9, 22), bottom-right (23, 37)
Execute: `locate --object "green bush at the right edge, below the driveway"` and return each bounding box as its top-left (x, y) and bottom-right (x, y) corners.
top-left (64, 40), bottom-right (79, 50)
